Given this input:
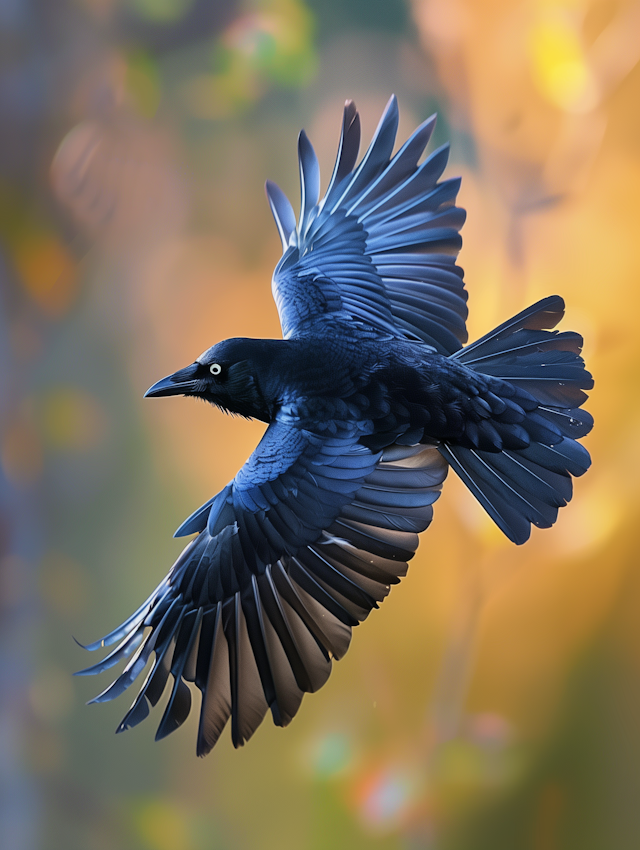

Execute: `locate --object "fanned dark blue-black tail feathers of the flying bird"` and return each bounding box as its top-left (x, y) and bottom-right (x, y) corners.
top-left (440, 296), bottom-right (593, 544)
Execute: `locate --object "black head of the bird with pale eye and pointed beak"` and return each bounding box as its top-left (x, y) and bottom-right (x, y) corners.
top-left (145, 339), bottom-right (271, 422)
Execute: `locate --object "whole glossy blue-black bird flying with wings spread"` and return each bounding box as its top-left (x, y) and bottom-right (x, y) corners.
top-left (77, 97), bottom-right (593, 755)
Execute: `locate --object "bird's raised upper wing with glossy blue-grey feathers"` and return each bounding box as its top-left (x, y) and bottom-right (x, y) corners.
top-left (267, 96), bottom-right (467, 354)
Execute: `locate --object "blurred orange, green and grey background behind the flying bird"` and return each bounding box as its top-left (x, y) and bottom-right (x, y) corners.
top-left (0, 0), bottom-right (640, 850)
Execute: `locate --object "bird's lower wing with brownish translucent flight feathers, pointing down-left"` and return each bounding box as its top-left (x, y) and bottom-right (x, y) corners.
top-left (81, 422), bottom-right (447, 755)
